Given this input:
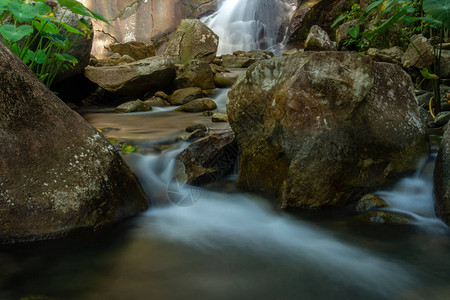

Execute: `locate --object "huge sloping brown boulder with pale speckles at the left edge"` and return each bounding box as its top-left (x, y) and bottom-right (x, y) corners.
top-left (0, 43), bottom-right (148, 244)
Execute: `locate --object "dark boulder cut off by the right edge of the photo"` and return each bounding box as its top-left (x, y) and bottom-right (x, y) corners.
top-left (434, 126), bottom-right (450, 225)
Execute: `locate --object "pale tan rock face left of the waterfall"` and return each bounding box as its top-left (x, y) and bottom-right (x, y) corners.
top-left (80, 0), bottom-right (217, 58)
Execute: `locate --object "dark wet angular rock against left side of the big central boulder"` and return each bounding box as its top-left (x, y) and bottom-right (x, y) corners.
top-left (175, 131), bottom-right (237, 185)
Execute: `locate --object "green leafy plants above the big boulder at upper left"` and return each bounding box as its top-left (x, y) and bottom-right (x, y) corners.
top-left (0, 0), bottom-right (107, 87)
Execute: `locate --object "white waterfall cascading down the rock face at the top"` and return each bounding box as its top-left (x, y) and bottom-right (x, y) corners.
top-left (202, 0), bottom-right (294, 55)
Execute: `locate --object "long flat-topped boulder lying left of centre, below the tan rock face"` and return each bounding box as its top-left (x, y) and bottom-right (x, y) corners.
top-left (84, 56), bottom-right (175, 96)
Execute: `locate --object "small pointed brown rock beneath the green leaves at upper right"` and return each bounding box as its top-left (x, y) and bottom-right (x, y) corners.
top-left (402, 35), bottom-right (434, 69)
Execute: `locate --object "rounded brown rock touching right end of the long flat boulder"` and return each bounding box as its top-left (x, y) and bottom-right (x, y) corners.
top-left (175, 60), bottom-right (216, 90)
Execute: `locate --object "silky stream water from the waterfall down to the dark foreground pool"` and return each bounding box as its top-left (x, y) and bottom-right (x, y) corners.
top-left (0, 0), bottom-right (450, 300)
